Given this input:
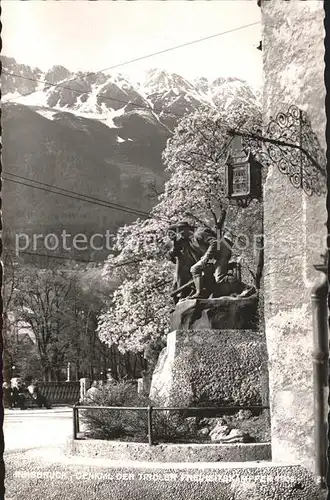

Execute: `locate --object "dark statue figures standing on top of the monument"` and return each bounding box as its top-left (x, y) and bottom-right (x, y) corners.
top-left (169, 222), bottom-right (233, 301)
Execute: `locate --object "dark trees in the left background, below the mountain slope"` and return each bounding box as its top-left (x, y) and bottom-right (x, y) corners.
top-left (3, 252), bottom-right (144, 380)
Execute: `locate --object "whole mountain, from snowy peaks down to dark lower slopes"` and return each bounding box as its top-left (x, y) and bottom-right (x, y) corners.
top-left (1, 57), bottom-right (257, 262)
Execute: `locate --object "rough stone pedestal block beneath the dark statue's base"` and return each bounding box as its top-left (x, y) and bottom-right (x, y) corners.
top-left (150, 329), bottom-right (268, 407)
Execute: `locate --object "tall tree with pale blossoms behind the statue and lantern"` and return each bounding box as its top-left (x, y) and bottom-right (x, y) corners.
top-left (98, 103), bottom-right (262, 364)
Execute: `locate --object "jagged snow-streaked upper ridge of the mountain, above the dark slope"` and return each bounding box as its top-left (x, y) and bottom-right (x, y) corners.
top-left (2, 57), bottom-right (257, 129)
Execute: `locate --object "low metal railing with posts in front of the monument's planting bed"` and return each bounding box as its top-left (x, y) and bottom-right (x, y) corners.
top-left (72, 405), bottom-right (269, 446)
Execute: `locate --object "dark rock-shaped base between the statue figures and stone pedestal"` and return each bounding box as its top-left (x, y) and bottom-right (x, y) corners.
top-left (172, 295), bottom-right (258, 330)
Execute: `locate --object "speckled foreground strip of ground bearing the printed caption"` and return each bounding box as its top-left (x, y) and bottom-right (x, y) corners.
top-left (6, 448), bottom-right (326, 500)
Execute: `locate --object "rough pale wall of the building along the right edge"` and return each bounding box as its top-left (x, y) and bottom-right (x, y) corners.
top-left (261, 0), bottom-right (327, 470)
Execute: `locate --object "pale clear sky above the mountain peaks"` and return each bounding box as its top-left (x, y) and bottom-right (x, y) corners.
top-left (2, 0), bottom-right (262, 88)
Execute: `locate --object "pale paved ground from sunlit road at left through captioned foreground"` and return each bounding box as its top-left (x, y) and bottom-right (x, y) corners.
top-left (1, 408), bottom-right (325, 500)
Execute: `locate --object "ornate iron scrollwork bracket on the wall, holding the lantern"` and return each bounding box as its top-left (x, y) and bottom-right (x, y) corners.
top-left (231, 106), bottom-right (326, 196)
